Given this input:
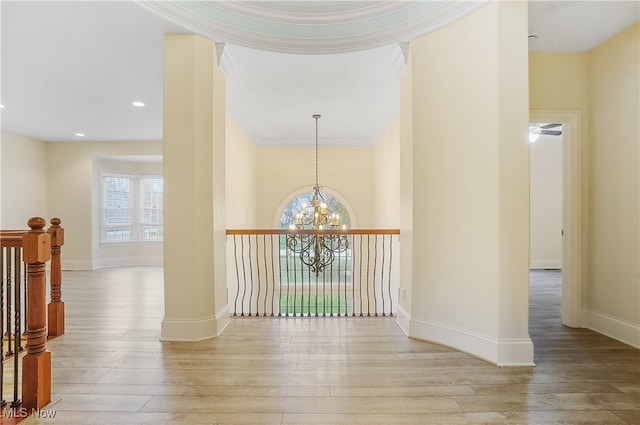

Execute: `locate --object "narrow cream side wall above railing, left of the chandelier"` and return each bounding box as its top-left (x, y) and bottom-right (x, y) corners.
top-left (225, 114), bottom-right (257, 229)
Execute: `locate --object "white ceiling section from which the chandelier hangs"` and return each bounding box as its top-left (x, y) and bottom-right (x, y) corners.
top-left (223, 45), bottom-right (402, 146)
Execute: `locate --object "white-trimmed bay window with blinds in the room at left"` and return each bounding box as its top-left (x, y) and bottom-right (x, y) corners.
top-left (100, 173), bottom-right (164, 242)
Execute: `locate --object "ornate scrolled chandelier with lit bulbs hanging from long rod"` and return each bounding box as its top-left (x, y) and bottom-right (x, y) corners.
top-left (287, 114), bottom-right (349, 276)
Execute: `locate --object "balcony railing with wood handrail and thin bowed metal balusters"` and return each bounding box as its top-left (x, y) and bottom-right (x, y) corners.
top-left (222, 229), bottom-right (400, 317)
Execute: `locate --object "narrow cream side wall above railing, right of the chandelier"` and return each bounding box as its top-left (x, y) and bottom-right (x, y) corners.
top-left (373, 118), bottom-right (401, 229)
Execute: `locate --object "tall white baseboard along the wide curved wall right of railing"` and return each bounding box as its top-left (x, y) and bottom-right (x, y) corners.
top-left (409, 318), bottom-right (535, 366)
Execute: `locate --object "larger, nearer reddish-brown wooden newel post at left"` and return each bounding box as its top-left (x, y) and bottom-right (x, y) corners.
top-left (22, 217), bottom-right (51, 409)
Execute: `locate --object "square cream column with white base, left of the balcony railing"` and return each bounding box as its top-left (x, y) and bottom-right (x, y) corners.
top-left (161, 35), bottom-right (229, 341)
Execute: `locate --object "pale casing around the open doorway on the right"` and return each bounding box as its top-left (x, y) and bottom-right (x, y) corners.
top-left (529, 110), bottom-right (583, 328)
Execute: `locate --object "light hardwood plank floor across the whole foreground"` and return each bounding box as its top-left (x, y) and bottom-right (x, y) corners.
top-left (13, 267), bottom-right (640, 425)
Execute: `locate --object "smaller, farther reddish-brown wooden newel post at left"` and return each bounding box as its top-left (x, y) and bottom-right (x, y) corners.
top-left (47, 218), bottom-right (64, 337)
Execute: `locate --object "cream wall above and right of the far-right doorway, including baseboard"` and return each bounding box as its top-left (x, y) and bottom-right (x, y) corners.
top-left (529, 23), bottom-right (640, 346)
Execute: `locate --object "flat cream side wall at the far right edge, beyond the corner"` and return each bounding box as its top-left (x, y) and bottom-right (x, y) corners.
top-left (586, 22), bottom-right (640, 346)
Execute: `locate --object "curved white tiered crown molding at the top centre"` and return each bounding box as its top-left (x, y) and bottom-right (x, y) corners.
top-left (138, 0), bottom-right (487, 54)
